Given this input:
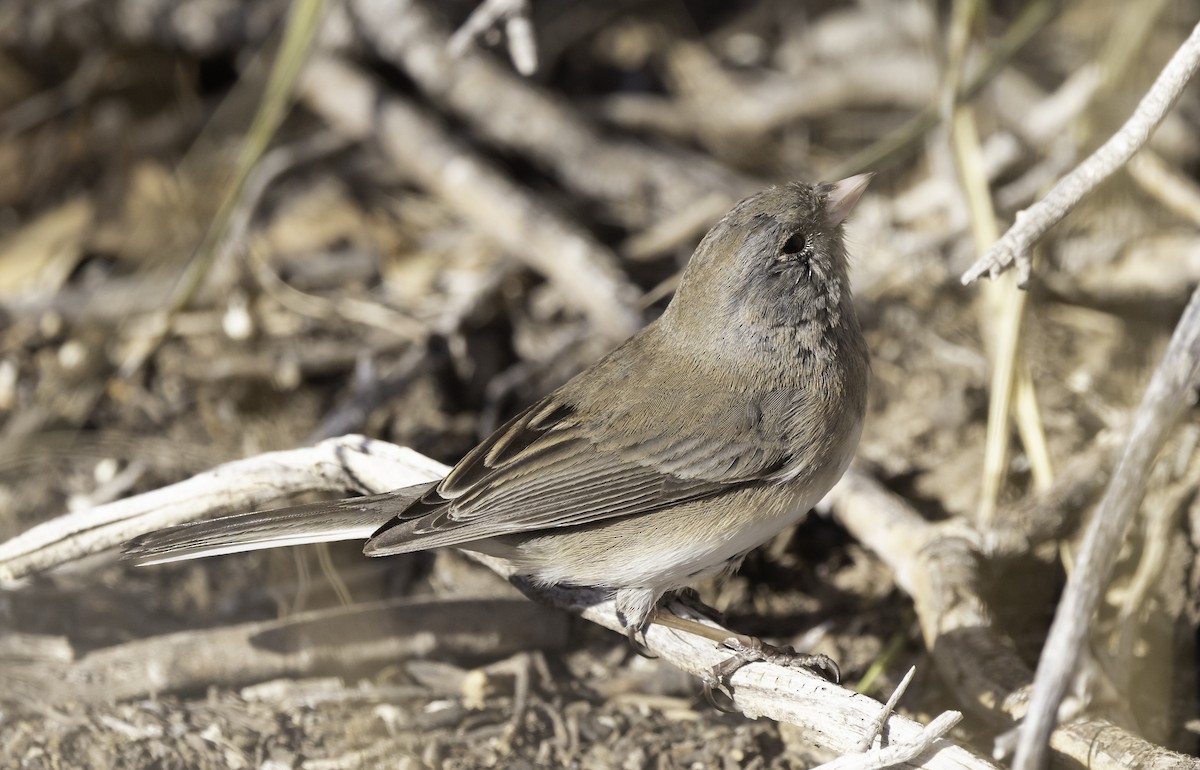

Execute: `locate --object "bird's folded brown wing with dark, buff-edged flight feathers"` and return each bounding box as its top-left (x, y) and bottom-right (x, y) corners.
top-left (365, 381), bottom-right (791, 555)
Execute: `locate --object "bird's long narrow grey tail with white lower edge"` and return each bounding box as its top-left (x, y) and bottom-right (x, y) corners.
top-left (125, 481), bottom-right (437, 565)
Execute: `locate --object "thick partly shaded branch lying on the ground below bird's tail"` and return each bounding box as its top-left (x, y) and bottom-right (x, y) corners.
top-left (0, 597), bottom-right (568, 709)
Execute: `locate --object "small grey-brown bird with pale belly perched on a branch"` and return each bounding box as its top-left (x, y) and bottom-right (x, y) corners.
top-left (127, 174), bottom-right (870, 666)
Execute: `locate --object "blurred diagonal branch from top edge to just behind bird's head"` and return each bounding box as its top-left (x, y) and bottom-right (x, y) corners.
top-left (323, 0), bottom-right (763, 229)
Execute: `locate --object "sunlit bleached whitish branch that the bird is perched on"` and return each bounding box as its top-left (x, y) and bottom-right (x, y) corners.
top-left (0, 435), bottom-right (994, 770)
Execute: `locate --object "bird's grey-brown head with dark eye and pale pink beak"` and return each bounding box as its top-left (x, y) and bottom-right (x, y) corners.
top-left (662, 174), bottom-right (874, 362)
